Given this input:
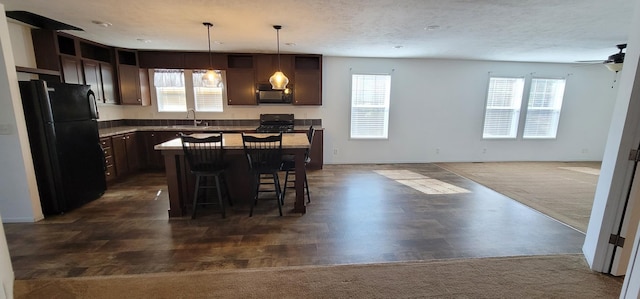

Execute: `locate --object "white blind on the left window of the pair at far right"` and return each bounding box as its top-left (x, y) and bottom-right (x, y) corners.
top-left (482, 77), bottom-right (524, 139)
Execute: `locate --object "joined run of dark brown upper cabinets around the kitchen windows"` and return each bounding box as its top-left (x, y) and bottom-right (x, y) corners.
top-left (31, 29), bottom-right (322, 106)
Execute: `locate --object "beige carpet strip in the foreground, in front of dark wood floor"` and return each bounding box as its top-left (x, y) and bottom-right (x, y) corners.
top-left (15, 255), bottom-right (622, 299)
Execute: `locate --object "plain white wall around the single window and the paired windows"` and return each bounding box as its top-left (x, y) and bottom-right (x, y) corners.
top-left (322, 57), bottom-right (616, 163)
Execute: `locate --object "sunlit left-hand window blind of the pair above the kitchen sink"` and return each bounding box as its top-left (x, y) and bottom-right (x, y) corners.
top-left (153, 69), bottom-right (187, 112)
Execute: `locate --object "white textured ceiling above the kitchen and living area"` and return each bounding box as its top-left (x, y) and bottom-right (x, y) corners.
top-left (0, 0), bottom-right (637, 62)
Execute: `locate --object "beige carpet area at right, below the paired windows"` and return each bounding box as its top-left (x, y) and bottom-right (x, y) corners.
top-left (437, 162), bottom-right (600, 233)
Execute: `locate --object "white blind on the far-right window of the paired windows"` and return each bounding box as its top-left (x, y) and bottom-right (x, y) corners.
top-left (522, 78), bottom-right (566, 139)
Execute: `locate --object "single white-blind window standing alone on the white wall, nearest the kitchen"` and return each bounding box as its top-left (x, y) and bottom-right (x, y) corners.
top-left (350, 74), bottom-right (391, 139)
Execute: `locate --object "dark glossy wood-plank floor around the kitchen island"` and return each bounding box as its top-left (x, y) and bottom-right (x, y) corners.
top-left (4, 164), bottom-right (584, 279)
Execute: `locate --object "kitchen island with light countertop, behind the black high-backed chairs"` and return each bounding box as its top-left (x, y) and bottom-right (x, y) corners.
top-left (154, 133), bottom-right (309, 218)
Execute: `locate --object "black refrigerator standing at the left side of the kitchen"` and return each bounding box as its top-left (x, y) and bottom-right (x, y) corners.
top-left (19, 80), bottom-right (107, 215)
